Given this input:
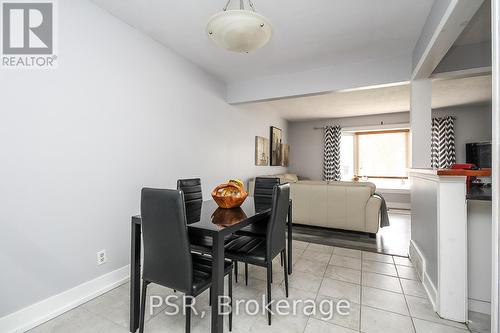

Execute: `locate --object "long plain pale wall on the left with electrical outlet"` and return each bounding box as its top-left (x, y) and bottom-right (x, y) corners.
top-left (0, 0), bottom-right (287, 317)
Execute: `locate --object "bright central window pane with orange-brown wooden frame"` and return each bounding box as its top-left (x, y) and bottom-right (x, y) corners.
top-left (354, 130), bottom-right (409, 179)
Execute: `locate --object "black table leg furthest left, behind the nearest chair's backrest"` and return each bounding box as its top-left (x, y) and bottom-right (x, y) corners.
top-left (130, 222), bottom-right (141, 333)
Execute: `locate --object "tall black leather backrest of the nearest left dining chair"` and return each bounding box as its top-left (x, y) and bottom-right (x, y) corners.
top-left (141, 188), bottom-right (193, 292)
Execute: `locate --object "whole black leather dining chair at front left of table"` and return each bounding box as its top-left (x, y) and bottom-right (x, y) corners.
top-left (139, 188), bottom-right (233, 333)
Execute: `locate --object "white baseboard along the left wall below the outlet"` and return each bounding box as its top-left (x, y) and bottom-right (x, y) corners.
top-left (0, 265), bottom-right (130, 333)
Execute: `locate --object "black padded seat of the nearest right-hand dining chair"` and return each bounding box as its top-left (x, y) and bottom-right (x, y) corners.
top-left (225, 236), bottom-right (266, 266)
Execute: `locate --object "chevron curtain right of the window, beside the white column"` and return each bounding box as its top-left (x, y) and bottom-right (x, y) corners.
top-left (431, 116), bottom-right (456, 169)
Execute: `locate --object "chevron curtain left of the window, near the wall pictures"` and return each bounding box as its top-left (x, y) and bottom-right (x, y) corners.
top-left (323, 126), bottom-right (342, 181)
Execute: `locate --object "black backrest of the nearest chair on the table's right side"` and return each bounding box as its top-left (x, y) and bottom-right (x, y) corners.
top-left (266, 184), bottom-right (290, 258)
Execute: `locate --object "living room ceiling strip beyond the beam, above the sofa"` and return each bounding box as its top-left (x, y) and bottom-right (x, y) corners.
top-left (250, 75), bottom-right (491, 121)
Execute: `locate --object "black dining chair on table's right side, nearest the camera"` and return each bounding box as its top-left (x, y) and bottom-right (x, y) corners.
top-left (225, 184), bottom-right (290, 325)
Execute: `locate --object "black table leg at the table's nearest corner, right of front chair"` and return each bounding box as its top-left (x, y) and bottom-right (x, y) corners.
top-left (210, 235), bottom-right (224, 333)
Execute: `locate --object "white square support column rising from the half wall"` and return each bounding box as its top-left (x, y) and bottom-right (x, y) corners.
top-left (410, 79), bottom-right (432, 169)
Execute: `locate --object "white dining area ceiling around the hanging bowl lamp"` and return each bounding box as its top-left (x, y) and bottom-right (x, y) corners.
top-left (93, 0), bottom-right (434, 82)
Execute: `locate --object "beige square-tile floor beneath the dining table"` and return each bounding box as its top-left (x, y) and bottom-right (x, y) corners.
top-left (31, 241), bottom-right (488, 333)
